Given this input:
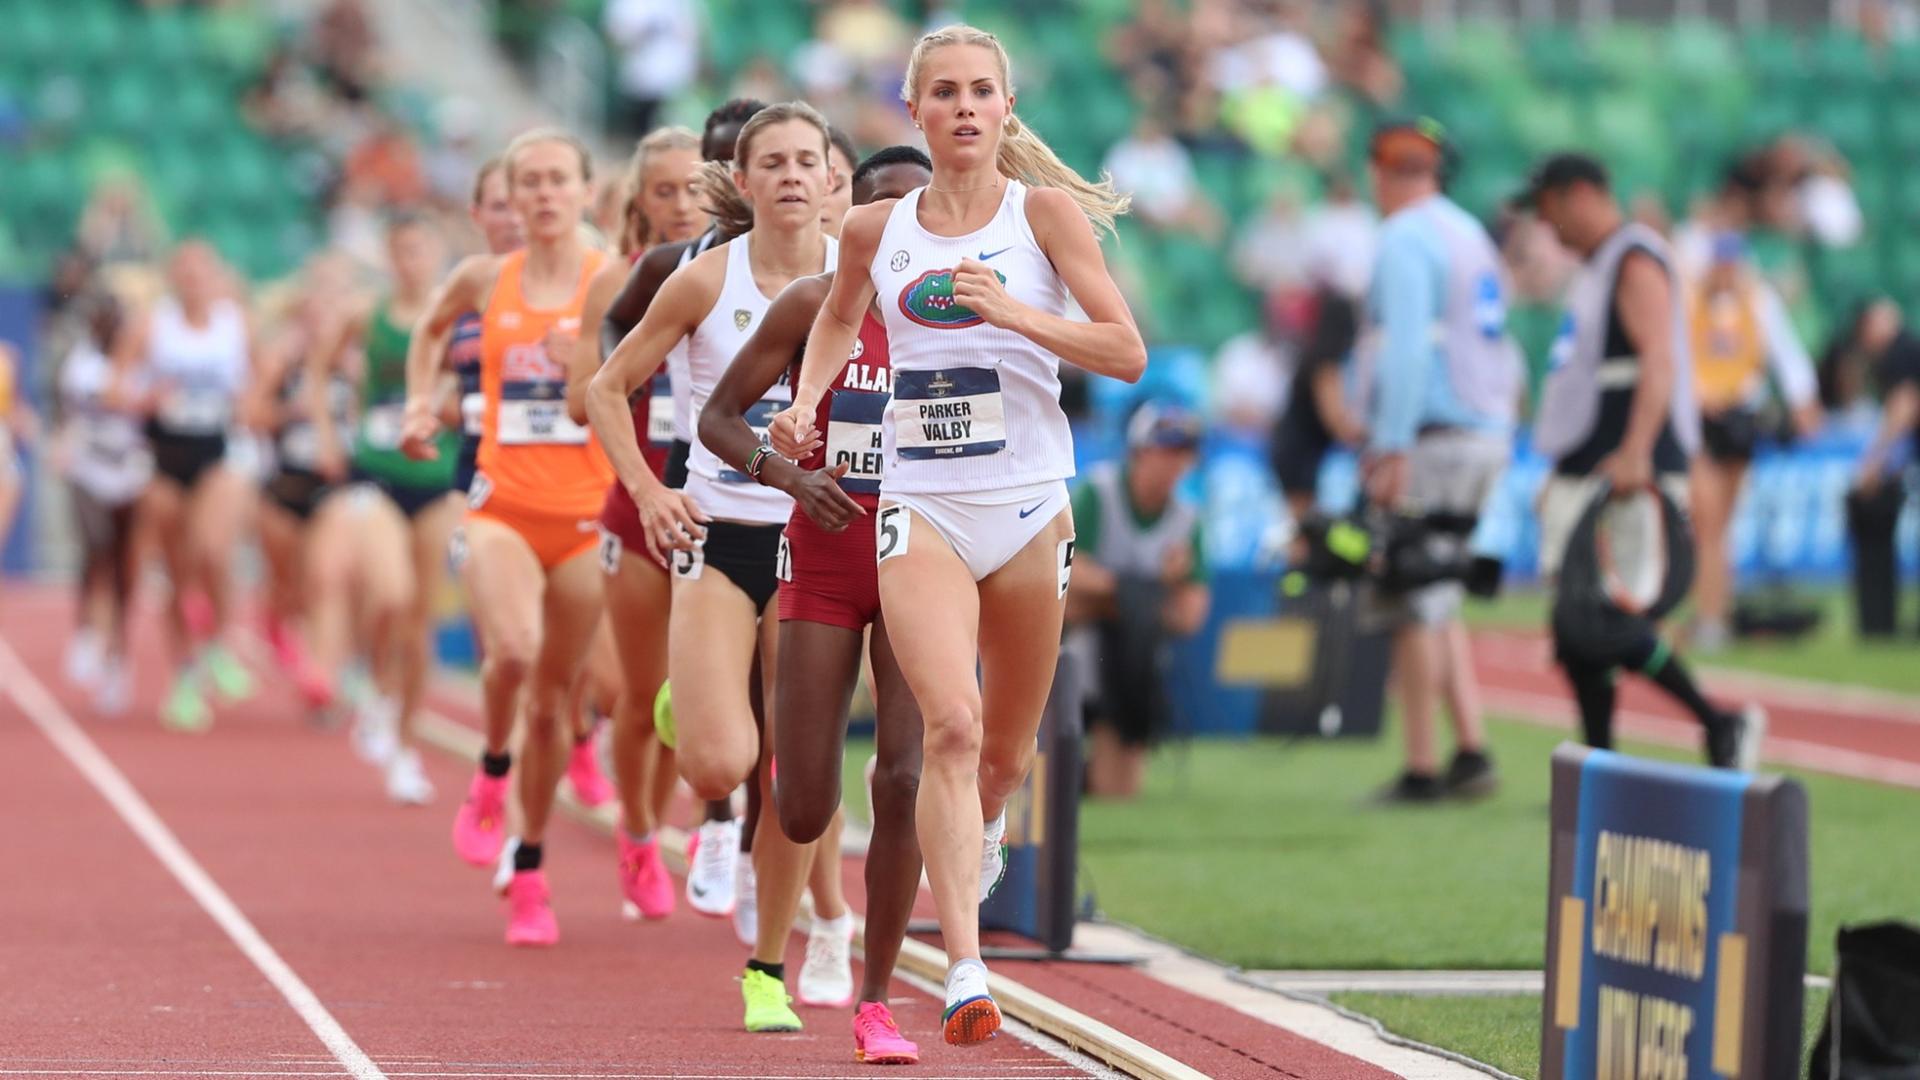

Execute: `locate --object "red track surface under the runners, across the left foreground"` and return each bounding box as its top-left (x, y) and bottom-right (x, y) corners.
top-left (0, 586), bottom-right (1386, 1078)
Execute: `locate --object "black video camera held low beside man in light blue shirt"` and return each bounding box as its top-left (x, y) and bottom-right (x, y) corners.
top-left (1300, 505), bottom-right (1503, 600)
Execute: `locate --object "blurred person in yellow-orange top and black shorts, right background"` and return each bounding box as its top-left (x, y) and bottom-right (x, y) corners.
top-left (1684, 233), bottom-right (1820, 651)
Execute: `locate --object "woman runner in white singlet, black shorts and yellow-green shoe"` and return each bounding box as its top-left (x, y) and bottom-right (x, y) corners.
top-left (588, 102), bottom-right (835, 1032)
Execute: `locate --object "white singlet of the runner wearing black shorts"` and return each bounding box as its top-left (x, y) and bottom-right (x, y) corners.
top-left (691, 233), bottom-right (839, 525)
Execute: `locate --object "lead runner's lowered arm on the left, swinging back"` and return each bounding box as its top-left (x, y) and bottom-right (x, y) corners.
top-left (768, 200), bottom-right (883, 457)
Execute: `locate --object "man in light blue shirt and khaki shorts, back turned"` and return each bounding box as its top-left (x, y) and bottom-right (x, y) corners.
top-left (1356, 119), bottom-right (1521, 801)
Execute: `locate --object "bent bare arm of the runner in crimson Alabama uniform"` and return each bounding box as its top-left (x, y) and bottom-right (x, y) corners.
top-left (699, 275), bottom-right (866, 532)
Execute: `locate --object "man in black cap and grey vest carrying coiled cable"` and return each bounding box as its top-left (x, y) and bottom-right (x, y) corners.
top-left (1521, 154), bottom-right (1764, 767)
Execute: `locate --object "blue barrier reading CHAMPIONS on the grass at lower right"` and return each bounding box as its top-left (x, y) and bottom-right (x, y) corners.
top-left (1540, 746), bottom-right (1807, 1080)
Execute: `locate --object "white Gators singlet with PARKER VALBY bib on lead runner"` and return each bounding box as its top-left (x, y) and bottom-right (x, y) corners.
top-left (870, 179), bottom-right (1073, 494)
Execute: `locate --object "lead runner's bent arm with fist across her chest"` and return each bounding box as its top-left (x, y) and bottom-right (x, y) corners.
top-left (954, 188), bottom-right (1146, 382)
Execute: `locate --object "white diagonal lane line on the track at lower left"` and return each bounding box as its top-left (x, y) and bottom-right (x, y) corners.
top-left (0, 640), bottom-right (386, 1080)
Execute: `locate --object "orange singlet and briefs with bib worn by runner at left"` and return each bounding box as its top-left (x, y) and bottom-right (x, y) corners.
top-left (467, 250), bottom-right (612, 571)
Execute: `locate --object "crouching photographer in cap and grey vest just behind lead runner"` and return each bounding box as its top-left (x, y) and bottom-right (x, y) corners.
top-left (1068, 402), bottom-right (1208, 798)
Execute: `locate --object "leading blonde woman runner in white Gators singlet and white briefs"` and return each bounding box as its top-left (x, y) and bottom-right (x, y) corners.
top-left (772, 27), bottom-right (1146, 1043)
